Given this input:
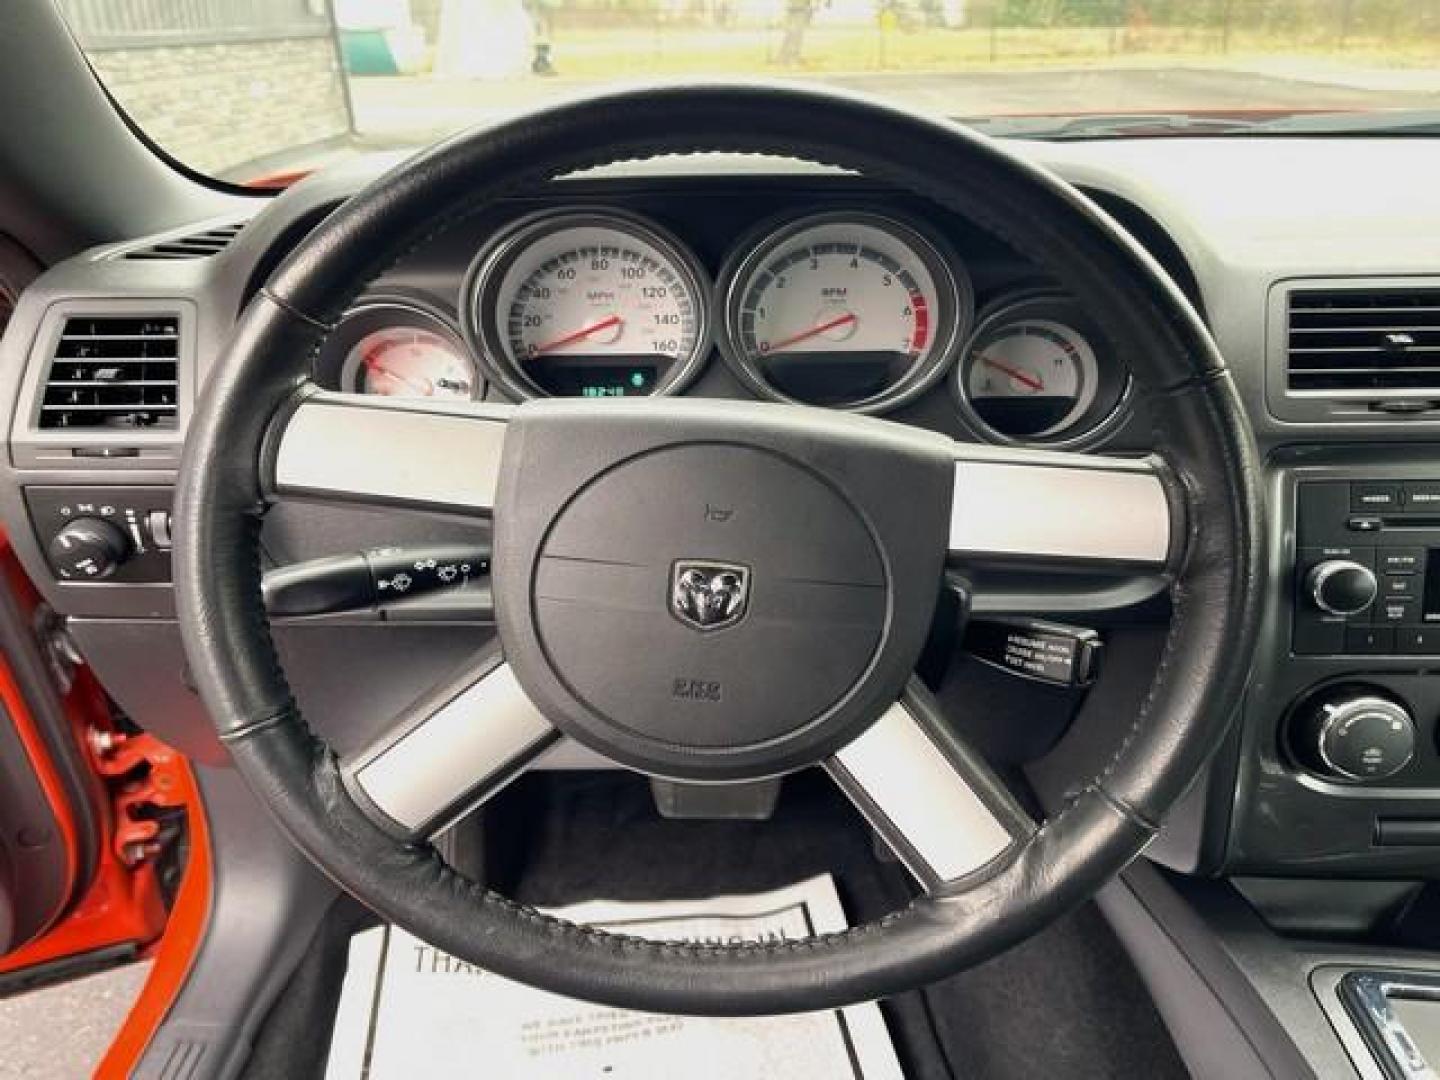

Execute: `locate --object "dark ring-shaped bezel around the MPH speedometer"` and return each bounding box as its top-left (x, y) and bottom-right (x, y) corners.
top-left (459, 206), bottom-right (713, 402)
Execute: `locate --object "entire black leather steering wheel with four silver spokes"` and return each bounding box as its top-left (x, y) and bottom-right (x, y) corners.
top-left (176, 85), bottom-right (1261, 1015)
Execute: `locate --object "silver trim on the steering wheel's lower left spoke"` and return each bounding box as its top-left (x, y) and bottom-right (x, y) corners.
top-left (354, 664), bottom-right (559, 832)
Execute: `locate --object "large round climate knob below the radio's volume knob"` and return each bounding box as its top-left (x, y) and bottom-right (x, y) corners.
top-left (1292, 688), bottom-right (1416, 780)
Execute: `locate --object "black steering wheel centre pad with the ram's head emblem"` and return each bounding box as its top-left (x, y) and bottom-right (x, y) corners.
top-left (492, 400), bottom-right (953, 780)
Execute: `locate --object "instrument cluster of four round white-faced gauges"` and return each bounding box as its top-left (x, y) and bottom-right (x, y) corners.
top-left (320, 206), bottom-right (1130, 446)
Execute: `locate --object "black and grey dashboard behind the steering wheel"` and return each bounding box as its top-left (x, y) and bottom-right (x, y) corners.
top-left (8, 138), bottom-right (1440, 877)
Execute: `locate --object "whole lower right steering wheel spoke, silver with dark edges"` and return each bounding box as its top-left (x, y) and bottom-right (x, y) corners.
top-left (825, 685), bottom-right (1035, 891)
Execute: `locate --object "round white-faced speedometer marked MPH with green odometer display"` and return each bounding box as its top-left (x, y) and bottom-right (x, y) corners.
top-left (465, 210), bottom-right (708, 397)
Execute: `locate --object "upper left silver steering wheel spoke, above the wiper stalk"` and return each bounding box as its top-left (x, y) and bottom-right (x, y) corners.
top-left (265, 390), bottom-right (511, 517)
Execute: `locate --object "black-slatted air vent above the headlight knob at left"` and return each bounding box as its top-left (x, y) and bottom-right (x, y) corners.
top-left (40, 315), bottom-right (180, 431)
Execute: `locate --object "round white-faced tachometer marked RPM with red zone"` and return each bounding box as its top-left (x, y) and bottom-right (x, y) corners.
top-left (721, 210), bottom-right (973, 412)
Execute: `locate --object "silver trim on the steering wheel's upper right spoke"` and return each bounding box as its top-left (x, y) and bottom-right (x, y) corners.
top-left (950, 446), bottom-right (1171, 566)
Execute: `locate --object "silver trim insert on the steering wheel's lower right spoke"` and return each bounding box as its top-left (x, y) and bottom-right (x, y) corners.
top-left (831, 703), bottom-right (1015, 883)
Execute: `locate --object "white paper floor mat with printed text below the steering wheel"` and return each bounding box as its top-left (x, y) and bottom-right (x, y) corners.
top-left (325, 874), bottom-right (903, 1080)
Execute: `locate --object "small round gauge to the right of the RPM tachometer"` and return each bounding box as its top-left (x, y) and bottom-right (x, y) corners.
top-left (956, 295), bottom-right (1129, 445)
